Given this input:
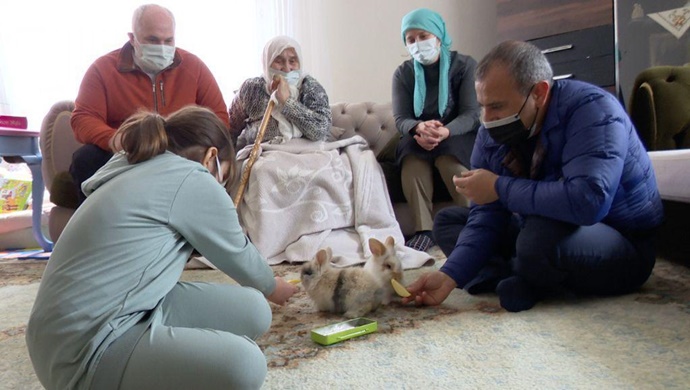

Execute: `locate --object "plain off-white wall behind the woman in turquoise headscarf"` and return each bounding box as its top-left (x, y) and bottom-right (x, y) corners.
top-left (296, 0), bottom-right (497, 104)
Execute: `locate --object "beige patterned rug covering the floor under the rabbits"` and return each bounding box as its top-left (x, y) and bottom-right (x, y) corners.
top-left (0, 252), bottom-right (690, 390)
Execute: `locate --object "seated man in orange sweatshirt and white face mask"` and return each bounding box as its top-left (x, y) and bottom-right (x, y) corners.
top-left (70, 4), bottom-right (229, 204)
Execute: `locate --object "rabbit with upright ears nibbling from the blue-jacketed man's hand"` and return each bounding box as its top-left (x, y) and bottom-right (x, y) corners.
top-left (364, 236), bottom-right (403, 305)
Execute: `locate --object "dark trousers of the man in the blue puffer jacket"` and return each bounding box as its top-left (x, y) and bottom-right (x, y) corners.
top-left (433, 207), bottom-right (655, 294)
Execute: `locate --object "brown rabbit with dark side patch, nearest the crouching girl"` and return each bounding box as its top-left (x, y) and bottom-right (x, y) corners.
top-left (300, 248), bottom-right (383, 318)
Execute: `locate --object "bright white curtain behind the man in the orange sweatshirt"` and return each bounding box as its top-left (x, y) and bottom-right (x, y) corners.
top-left (0, 0), bottom-right (286, 130)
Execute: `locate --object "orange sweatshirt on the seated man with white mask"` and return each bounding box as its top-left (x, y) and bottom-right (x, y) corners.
top-left (71, 42), bottom-right (229, 150)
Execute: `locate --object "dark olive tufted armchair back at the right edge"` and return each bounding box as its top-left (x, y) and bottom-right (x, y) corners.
top-left (629, 65), bottom-right (690, 151)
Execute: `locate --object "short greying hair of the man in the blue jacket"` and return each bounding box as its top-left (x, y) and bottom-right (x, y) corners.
top-left (475, 41), bottom-right (553, 95)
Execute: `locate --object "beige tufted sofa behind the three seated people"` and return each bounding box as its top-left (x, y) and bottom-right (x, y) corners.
top-left (40, 101), bottom-right (451, 241)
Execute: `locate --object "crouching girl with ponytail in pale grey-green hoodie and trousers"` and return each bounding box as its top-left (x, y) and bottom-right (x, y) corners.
top-left (26, 106), bottom-right (297, 389)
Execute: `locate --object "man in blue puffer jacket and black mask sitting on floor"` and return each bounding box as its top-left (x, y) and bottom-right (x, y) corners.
top-left (404, 41), bottom-right (663, 312)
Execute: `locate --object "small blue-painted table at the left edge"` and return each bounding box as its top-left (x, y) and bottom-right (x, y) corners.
top-left (0, 128), bottom-right (53, 252)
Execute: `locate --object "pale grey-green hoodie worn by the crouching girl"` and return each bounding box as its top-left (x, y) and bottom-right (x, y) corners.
top-left (26, 152), bottom-right (275, 389)
